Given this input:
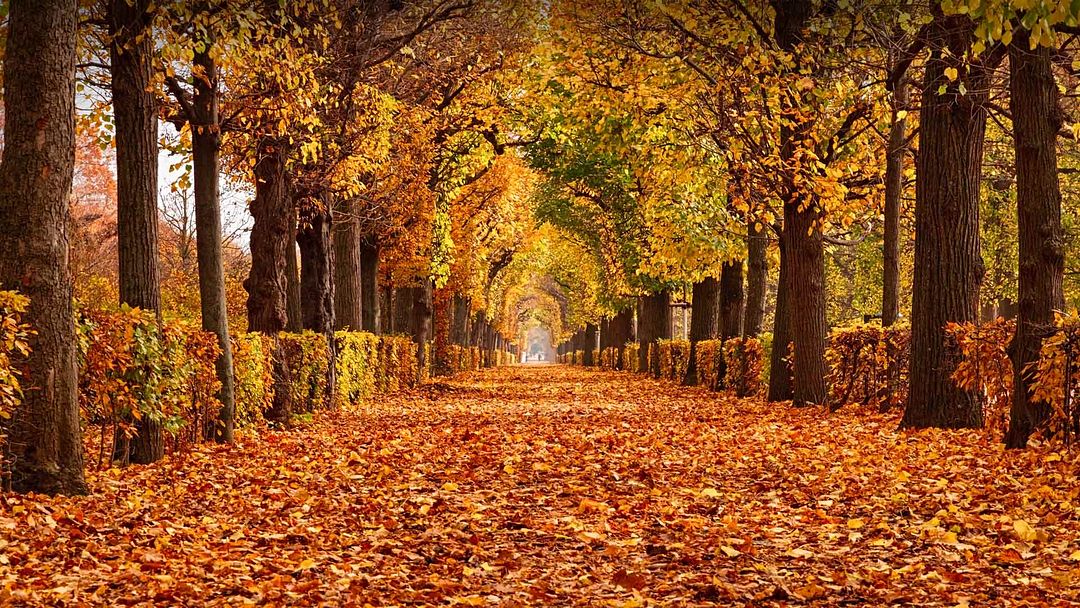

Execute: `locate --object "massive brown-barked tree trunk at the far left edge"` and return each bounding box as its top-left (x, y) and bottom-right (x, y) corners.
top-left (0, 0), bottom-right (86, 495)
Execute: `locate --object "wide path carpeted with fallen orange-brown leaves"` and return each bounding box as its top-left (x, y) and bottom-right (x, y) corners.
top-left (0, 366), bottom-right (1080, 606)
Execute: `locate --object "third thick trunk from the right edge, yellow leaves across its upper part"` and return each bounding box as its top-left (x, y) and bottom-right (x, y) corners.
top-left (775, 0), bottom-right (828, 406)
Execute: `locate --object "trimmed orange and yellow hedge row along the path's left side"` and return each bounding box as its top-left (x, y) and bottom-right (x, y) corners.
top-left (0, 302), bottom-right (514, 477)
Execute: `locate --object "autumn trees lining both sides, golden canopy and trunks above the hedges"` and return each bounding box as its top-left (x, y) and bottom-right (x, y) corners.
top-left (0, 0), bottom-right (1080, 494)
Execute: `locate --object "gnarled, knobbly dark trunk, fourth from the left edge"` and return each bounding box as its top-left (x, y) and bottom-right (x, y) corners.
top-left (244, 138), bottom-right (295, 425)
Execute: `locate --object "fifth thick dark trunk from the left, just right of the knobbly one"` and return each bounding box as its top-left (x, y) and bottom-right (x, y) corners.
top-left (296, 194), bottom-right (337, 407)
